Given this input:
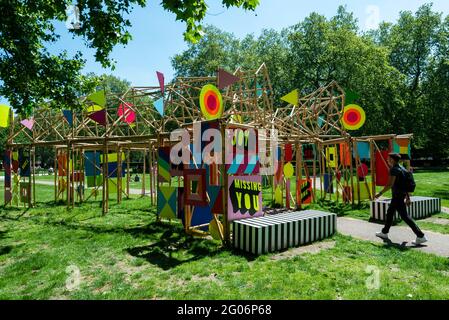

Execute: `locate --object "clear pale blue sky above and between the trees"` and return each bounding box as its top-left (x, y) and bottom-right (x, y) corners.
top-left (2, 0), bottom-right (449, 104)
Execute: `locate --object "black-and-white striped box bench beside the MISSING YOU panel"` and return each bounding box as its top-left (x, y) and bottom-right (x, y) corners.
top-left (232, 210), bottom-right (337, 254)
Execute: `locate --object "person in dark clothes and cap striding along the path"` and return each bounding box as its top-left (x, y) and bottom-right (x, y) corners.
top-left (375, 153), bottom-right (427, 245)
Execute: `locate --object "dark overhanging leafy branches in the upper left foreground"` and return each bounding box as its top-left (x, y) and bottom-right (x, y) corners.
top-left (0, 0), bottom-right (259, 115)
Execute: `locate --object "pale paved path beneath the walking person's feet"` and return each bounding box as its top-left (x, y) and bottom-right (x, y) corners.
top-left (337, 217), bottom-right (449, 258)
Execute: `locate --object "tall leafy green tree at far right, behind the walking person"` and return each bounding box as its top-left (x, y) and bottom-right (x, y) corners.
top-left (376, 4), bottom-right (449, 158)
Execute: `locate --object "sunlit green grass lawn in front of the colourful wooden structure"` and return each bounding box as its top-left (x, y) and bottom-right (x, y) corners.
top-left (0, 186), bottom-right (449, 299)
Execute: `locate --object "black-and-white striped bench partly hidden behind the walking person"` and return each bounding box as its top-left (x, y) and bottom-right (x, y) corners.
top-left (370, 197), bottom-right (441, 221)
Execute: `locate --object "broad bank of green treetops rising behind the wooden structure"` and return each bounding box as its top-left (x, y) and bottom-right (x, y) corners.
top-left (172, 5), bottom-right (449, 159)
